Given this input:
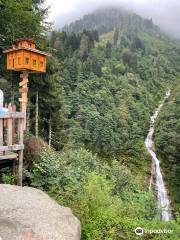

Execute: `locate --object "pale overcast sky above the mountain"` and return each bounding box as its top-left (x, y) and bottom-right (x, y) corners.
top-left (47, 0), bottom-right (180, 36)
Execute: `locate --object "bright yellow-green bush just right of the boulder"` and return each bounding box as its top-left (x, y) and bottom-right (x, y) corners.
top-left (76, 173), bottom-right (125, 239)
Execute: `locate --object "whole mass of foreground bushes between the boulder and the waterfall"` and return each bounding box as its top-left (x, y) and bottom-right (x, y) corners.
top-left (26, 149), bottom-right (166, 240)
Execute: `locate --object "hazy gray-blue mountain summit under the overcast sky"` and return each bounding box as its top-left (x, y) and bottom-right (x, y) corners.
top-left (63, 7), bottom-right (159, 34)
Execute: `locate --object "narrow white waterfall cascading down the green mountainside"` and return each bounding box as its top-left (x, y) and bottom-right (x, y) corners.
top-left (145, 90), bottom-right (172, 221)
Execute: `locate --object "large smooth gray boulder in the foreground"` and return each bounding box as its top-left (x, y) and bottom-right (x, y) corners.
top-left (0, 184), bottom-right (80, 240)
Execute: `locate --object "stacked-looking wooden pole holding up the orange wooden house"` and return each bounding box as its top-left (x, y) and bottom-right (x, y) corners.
top-left (19, 71), bottom-right (28, 130)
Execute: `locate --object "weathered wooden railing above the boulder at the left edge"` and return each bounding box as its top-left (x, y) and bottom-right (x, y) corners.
top-left (0, 105), bottom-right (25, 185)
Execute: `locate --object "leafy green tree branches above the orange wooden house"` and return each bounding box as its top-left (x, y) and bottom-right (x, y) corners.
top-left (0, 0), bottom-right (47, 47)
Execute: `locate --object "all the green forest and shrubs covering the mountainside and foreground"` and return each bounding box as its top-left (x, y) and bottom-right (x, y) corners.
top-left (0, 0), bottom-right (180, 240)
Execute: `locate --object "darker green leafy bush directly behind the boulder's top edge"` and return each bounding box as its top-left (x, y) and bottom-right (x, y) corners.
top-left (26, 148), bottom-right (100, 194)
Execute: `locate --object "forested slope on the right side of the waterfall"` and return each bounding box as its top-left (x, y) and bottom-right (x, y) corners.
top-left (155, 82), bottom-right (180, 214)
